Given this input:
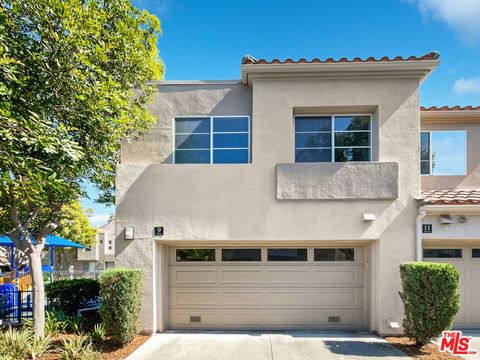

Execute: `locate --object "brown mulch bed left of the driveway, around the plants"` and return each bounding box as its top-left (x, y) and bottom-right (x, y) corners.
top-left (40, 334), bottom-right (150, 360)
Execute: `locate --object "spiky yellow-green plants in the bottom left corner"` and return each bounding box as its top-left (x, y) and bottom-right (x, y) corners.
top-left (0, 327), bottom-right (52, 360)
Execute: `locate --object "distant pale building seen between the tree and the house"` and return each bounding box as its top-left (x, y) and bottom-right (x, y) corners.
top-left (77, 220), bottom-right (115, 271)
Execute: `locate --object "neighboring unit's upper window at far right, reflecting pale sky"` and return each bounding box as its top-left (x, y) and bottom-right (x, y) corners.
top-left (420, 131), bottom-right (467, 175)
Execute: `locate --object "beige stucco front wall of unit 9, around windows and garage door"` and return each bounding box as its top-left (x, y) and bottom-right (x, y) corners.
top-left (116, 79), bottom-right (420, 333)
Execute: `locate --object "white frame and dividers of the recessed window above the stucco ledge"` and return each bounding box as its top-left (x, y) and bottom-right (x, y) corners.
top-left (293, 113), bottom-right (373, 164)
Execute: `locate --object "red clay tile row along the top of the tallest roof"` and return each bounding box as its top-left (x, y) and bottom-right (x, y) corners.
top-left (242, 51), bottom-right (440, 65)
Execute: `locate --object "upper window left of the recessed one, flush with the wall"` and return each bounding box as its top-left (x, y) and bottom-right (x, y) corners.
top-left (173, 116), bottom-right (250, 164)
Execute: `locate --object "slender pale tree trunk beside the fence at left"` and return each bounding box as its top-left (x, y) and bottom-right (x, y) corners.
top-left (29, 246), bottom-right (45, 337)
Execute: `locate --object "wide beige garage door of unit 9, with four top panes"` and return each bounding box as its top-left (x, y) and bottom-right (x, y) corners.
top-left (168, 247), bottom-right (365, 329)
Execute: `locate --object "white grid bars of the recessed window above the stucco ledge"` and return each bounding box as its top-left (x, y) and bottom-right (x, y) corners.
top-left (294, 114), bottom-right (372, 162)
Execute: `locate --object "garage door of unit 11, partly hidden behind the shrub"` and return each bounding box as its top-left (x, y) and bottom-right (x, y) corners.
top-left (423, 245), bottom-right (480, 329)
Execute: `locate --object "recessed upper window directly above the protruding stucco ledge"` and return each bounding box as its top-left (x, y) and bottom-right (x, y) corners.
top-left (295, 115), bottom-right (372, 162)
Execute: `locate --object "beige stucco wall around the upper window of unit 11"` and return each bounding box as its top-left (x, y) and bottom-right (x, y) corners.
top-left (421, 117), bottom-right (480, 190)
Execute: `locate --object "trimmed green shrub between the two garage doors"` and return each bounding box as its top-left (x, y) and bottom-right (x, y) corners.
top-left (400, 262), bottom-right (460, 345)
